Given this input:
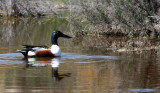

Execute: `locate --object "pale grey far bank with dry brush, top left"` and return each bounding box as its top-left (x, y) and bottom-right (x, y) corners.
top-left (0, 0), bottom-right (79, 17)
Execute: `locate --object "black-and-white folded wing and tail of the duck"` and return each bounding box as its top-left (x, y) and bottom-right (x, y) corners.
top-left (17, 45), bottom-right (49, 56)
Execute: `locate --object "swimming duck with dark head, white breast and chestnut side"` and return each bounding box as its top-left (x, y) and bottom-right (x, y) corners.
top-left (18, 31), bottom-right (72, 57)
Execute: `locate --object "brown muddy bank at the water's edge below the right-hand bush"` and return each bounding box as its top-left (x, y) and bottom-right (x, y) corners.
top-left (73, 16), bottom-right (160, 52)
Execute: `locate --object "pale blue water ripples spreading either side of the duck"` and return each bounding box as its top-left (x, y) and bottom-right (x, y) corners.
top-left (0, 53), bottom-right (119, 64)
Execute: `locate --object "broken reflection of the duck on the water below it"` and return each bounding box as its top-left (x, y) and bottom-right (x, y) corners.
top-left (24, 57), bottom-right (71, 81)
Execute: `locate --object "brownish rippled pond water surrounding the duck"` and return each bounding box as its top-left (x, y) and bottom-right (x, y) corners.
top-left (0, 17), bottom-right (160, 93)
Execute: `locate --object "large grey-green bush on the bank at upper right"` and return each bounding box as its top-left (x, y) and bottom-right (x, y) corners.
top-left (73, 0), bottom-right (160, 39)
